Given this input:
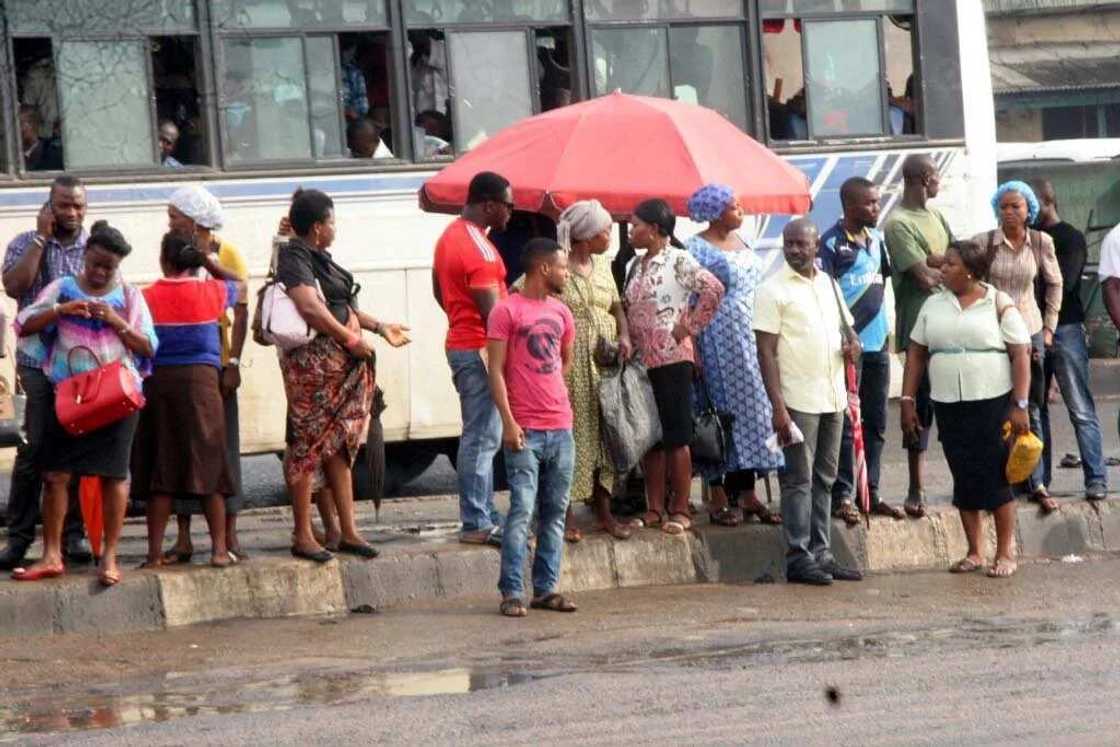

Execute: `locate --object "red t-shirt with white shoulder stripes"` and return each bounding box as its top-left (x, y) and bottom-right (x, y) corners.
top-left (432, 217), bottom-right (506, 351)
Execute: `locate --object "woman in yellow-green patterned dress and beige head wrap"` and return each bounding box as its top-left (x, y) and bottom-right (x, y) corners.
top-left (557, 199), bottom-right (631, 542)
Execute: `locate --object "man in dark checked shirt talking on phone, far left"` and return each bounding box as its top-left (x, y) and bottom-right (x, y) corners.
top-left (0, 175), bottom-right (93, 570)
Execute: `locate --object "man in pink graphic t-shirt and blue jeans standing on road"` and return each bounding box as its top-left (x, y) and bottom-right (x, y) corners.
top-left (486, 239), bottom-right (576, 617)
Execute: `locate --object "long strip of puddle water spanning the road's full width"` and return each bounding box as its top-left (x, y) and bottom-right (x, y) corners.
top-left (0, 614), bottom-right (1120, 741)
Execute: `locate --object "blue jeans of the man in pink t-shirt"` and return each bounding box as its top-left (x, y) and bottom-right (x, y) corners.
top-left (497, 430), bottom-right (576, 599)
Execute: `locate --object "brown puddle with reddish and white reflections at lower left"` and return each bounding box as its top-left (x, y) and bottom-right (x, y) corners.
top-left (0, 669), bottom-right (542, 743)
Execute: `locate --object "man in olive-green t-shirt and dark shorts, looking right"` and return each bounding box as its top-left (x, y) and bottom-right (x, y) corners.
top-left (884, 153), bottom-right (953, 519)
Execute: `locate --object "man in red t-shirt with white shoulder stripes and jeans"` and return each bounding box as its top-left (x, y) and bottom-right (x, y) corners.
top-left (431, 171), bottom-right (513, 547)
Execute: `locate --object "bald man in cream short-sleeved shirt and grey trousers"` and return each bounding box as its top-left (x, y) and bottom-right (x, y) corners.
top-left (754, 218), bottom-right (862, 586)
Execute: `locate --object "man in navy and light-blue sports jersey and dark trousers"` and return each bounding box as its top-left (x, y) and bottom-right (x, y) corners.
top-left (818, 177), bottom-right (906, 525)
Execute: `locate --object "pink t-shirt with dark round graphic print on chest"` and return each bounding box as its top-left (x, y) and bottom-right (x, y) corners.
top-left (487, 293), bottom-right (576, 430)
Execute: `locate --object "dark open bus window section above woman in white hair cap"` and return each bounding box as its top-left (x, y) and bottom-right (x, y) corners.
top-left (151, 36), bottom-right (211, 168)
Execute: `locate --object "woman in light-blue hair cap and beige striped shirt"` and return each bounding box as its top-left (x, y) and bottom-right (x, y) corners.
top-left (973, 181), bottom-right (1062, 513)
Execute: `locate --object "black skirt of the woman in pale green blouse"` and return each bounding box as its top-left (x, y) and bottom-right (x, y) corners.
top-left (934, 394), bottom-right (1014, 511)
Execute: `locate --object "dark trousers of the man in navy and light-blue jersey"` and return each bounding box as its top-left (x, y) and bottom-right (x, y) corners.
top-left (832, 351), bottom-right (890, 507)
